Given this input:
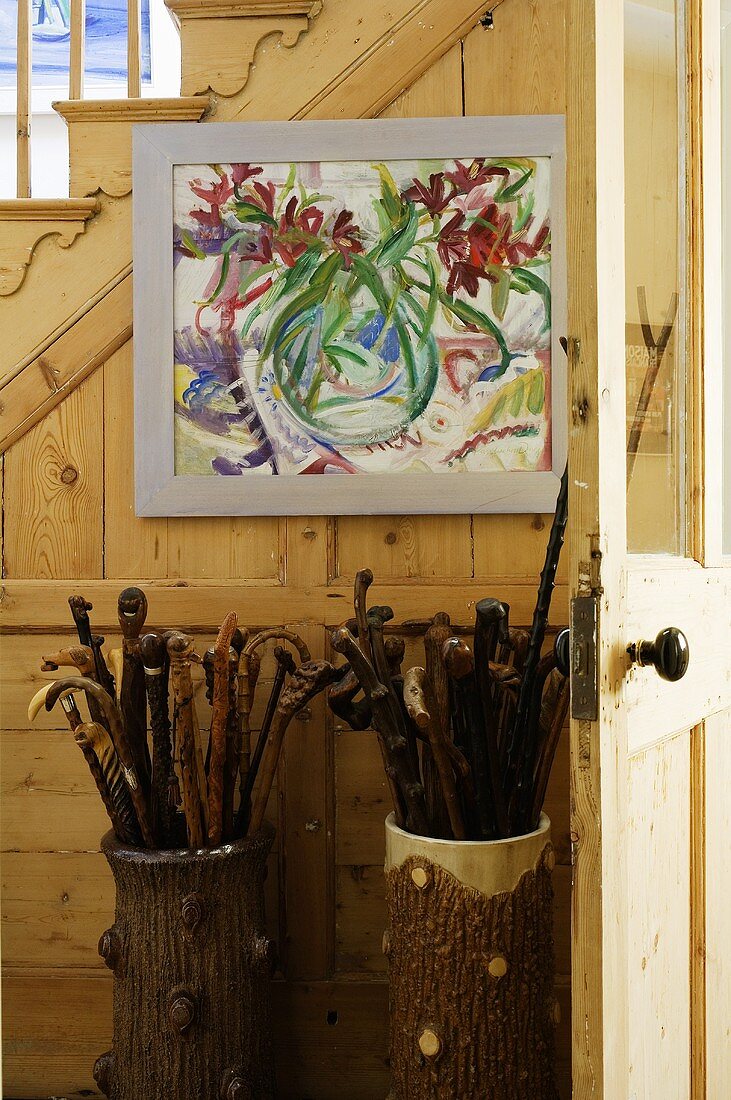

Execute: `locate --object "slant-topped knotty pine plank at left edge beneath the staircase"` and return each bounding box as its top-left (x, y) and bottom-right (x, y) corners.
top-left (4, 375), bottom-right (103, 580)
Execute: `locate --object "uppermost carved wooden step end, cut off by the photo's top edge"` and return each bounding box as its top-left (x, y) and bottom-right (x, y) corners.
top-left (165, 0), bottom-right (322, 96)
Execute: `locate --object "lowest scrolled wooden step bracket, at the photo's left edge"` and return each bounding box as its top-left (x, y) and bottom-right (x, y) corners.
top-left (0, 199), bottom-right (99, 295)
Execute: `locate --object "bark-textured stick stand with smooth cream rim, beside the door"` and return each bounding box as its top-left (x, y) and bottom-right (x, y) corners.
top-left (384, 814), bottom-right (557, 1100)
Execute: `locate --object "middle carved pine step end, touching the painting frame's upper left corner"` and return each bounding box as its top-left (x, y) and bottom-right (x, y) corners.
top-left (53, 96), bottom-right (211, 197)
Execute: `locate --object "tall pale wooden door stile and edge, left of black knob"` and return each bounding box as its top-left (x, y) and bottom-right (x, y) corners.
top-left (567, 0), bottom-right (629, 1100)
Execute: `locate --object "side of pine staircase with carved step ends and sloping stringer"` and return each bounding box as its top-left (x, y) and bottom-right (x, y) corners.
top-left (0, 0), bottom-right (489, 451)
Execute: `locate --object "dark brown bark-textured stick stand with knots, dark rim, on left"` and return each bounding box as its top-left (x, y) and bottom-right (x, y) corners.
top-left (95, 827), bottom-right (275, 1100)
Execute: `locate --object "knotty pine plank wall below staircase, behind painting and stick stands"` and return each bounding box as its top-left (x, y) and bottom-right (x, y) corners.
top-left (0, 0), bottom-right (571, 1100)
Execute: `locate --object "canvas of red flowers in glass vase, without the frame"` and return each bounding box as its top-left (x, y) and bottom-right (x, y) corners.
top-left (174, 157), bottom-right (551, 476)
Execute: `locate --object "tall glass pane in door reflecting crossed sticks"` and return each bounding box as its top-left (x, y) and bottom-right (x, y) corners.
top-left (624, 0), bottom-right (686, 554)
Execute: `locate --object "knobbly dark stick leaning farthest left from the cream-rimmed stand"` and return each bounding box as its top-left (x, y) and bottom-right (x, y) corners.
top-left (331, 627), bottom-right (429, 836)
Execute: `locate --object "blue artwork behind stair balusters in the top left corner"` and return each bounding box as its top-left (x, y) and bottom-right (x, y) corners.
top-left (0, 0), bottom-right (152, 88)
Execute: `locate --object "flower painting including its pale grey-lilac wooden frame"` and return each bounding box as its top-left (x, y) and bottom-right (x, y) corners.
top-left (134, 116), bottom-right (566, 516)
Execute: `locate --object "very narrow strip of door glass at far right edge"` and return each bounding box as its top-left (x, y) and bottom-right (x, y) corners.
top-left (721, 0), bottom-right (731, 554)
